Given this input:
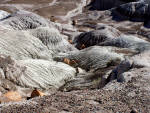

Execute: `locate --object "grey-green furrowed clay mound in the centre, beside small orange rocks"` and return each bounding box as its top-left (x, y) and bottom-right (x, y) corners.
top-left (54, 46), bottom-right (123, 70)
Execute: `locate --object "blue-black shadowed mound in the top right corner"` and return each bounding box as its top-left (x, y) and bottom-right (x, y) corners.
top-left (113, 1), bottom-right (150, 21)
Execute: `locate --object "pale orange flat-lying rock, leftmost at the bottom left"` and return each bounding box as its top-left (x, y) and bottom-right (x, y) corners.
top-left (3, 91), bottom-right (22, 101)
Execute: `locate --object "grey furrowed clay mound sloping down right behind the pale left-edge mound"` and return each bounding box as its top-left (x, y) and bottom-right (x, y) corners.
top-left (29, 27), bottom-right (76, 54)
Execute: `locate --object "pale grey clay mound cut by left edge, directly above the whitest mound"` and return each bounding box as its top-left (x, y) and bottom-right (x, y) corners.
top-left (0, 30), bottom-right (51, 60)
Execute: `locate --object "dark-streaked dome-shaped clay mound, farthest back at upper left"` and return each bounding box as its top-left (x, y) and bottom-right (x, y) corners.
top-left (0, 10), bottom-right (48, 30)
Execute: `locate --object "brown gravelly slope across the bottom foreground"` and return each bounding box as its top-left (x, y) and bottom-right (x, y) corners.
top-left (0, 68), bottom-right (150, 113)
